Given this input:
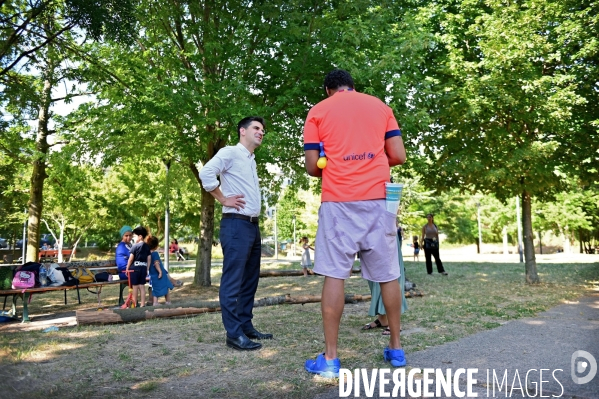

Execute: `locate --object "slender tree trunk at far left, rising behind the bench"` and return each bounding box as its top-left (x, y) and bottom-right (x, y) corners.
top-left (27, 61), bottom-right (54, 261)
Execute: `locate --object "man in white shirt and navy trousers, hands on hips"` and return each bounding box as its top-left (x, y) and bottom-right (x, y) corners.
top-left (200, 116), bottom-right (273, 351)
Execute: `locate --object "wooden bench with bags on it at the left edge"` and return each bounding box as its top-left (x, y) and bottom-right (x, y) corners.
top-left (0, 260), bottom-right (128, 323)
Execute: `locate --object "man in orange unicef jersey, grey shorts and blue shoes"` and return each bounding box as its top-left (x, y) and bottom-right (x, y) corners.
top-left (304, 70), bottom-right (406, 378)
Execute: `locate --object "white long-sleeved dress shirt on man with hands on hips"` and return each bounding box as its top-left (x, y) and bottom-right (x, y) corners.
top-left (200, 143), bottom-right (261, 216)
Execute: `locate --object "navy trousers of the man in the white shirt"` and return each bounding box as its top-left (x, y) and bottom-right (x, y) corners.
top-left (218, 219), bottom-right (262, 338)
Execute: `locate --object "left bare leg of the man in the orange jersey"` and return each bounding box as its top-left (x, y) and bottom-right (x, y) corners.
top-left (321, 277), bottom-right (344, 360)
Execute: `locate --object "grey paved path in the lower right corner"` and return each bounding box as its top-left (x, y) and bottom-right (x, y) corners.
top-left (315, 293), bottom-right (599, 399)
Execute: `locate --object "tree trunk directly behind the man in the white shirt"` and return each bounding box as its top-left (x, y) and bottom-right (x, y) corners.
top-left (193, 188), bottom-right (215, 287)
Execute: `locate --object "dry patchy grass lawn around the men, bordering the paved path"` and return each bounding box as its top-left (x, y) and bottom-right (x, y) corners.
top-left (0, 252), bottom-right (599, 398)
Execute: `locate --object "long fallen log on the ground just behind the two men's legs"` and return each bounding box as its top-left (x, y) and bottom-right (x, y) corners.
top-left (75, 294), bottom-right (370, 325)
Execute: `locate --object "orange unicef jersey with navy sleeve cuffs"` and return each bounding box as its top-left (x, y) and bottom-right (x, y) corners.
top-left (304, 90), bottom-right (401, 202)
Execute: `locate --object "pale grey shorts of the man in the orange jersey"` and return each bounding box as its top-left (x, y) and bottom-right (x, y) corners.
top-left (314, 200), bottom-right (400, 283)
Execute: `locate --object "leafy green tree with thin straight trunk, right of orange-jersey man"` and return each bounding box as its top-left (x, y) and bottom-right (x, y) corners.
top-left (414, 0), bottom-right (593, 283)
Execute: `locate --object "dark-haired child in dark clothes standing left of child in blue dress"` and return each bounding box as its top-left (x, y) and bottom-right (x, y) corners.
top-left (126, 226), bottom-right (152, 307)
